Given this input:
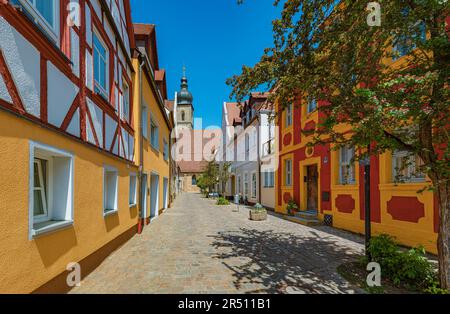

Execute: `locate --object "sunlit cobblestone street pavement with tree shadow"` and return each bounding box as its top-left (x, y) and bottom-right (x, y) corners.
top-left (72, 194), bottom-right (363, 294)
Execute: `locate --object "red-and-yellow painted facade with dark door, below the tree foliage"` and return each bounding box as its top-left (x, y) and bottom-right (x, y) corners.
top-left (276, 58), bottom-right (439, 253)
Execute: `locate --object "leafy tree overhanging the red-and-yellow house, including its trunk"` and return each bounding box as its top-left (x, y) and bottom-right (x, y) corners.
top-left (227, 0), bottom-right (450, 289)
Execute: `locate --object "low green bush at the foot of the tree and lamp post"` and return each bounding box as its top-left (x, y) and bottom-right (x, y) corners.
top-left (368, 235), bottom-right (444, 293)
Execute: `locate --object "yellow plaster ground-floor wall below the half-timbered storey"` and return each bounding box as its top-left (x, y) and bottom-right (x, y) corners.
top-left (0, 111), bottom-right (138, 293)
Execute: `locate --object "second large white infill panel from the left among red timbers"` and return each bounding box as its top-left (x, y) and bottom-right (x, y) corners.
top-left (47, 62), bottom-right (79, 127)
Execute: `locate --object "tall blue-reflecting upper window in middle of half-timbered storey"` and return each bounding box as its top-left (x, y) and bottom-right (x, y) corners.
top-left (93, 32), bottom-right (108, 98)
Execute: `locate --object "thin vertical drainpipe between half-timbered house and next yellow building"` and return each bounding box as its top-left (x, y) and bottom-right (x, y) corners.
top-left (136, 49), bottom-right (145, 234)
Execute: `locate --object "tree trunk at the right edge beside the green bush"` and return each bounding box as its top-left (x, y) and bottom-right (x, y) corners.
top-left (437, 182), bottom-right (450, 290)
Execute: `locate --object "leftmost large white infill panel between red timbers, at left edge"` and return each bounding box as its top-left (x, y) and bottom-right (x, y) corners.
top-left (0, 17), bottom-right (41, 117)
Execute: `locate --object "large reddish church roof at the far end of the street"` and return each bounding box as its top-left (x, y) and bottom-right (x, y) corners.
top-left (176, 129), bottom-right (222, 173)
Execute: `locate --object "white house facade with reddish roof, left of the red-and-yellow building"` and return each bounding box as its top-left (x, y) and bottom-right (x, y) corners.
top-left (222, 93), bottom-right (277, 209)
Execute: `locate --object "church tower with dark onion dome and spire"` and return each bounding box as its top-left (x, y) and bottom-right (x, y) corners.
top-left (176, 67), bottom-right (194, 130)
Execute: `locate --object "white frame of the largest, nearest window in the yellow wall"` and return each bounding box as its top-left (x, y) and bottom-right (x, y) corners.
top-left (28, 141), bottom-right (74, 241)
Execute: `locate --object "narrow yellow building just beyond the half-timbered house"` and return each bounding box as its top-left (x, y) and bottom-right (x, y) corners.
top-left (133, 24), bottom-right (173, 226)
